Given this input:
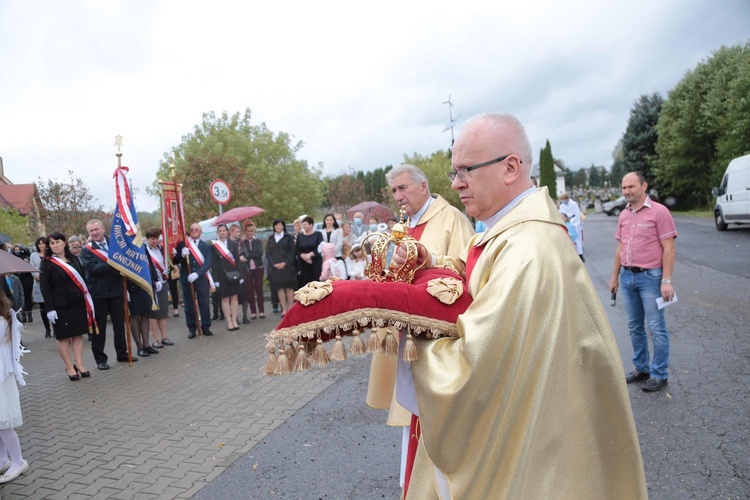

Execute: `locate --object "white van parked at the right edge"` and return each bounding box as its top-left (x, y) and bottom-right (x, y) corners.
top-left (711, 155), bottom-right (750, 231)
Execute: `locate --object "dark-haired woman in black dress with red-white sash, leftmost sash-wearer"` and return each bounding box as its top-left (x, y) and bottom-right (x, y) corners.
top-left (39, 232), bottom-right (96, 381)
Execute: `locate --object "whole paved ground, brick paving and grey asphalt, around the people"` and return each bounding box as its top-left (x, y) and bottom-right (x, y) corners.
top-left (0, 215), bottom-right (750, 499)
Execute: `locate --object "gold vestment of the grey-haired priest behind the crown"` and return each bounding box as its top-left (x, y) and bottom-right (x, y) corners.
top-left (366, 194), bottom-right (474, 426)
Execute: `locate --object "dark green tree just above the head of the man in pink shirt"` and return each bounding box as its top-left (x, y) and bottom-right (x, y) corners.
top-left (622, 93), bottom-right (664, 186)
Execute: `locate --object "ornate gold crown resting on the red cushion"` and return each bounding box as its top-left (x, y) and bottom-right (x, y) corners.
top-left (362, 208), bottom-right (427, 283)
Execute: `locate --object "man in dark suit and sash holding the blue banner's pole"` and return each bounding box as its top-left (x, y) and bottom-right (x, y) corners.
top-left (78, 219), bottom-right (138, 370)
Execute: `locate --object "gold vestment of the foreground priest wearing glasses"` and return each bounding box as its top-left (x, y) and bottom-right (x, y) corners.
top-left (408, 188), bottom-right (647, 500)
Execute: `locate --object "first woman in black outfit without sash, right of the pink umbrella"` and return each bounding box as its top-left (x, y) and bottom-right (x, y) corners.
top-left (266, 219), bottom-right (297, 317)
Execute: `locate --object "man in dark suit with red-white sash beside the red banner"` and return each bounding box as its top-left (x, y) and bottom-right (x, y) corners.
top-left (172, 223), bottom-right (213, 339)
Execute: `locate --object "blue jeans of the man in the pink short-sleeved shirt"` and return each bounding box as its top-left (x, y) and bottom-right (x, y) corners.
top-left (620, 268), bottom-right (669, 380)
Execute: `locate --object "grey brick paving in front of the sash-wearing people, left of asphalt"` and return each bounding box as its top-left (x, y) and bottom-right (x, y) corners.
top-left (0, 311), bottom-right (330, 499)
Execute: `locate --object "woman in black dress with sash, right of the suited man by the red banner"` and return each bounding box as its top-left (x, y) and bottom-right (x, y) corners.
top-left (211, 224), bottom-right (244, 332)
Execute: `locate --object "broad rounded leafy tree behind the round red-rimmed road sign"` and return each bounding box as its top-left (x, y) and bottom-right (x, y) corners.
top-left (156, 108), bottom-right (323, 225)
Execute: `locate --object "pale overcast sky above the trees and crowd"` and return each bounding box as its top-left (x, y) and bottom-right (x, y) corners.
top-left (0, 0), bottom-right (750, 211)
